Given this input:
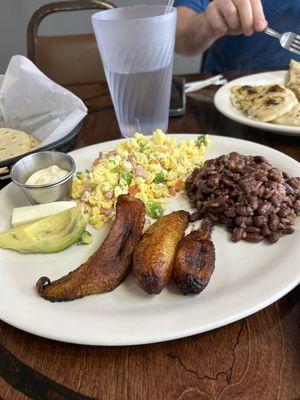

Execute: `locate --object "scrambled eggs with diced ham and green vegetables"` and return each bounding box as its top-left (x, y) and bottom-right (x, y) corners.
top-left (72, 130), bottom-right (208, 229)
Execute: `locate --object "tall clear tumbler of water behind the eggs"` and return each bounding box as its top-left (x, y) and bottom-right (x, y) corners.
top-left (92, 6), bottom-right (176, 137)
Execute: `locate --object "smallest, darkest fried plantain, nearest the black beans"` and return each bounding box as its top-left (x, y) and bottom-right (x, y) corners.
top-left (173, 219), bottom-right (216, 294)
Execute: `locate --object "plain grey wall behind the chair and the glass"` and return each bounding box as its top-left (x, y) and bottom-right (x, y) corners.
top-left (0, 0), bottom-right (200, 74)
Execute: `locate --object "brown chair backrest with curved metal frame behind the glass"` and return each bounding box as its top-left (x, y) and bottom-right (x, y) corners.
top-left (27, 0), bottom-right (115, 85)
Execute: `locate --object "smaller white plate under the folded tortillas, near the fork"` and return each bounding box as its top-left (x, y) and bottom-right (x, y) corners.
top-left (214, 71), bottom-right (300, 136)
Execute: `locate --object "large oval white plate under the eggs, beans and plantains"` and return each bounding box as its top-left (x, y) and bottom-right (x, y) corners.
top-left (0, 135), bottom-right (300, 345)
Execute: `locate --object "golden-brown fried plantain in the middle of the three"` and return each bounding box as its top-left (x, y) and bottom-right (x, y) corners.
top-left (132, 211), bottom-right (189, 294)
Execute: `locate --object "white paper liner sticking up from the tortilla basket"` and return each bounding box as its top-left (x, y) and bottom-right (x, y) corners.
top-left (0, 56), bottom-right (87, 147)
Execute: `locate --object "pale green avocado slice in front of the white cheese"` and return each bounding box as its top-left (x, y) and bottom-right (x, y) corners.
top-left (0, 205), bottom-right (87, 253)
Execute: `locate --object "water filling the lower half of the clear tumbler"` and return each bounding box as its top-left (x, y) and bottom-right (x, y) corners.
top-left (105, 64), bottom-right (172, 137)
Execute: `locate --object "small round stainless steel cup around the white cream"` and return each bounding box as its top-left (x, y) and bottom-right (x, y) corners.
top-left (10, 151), bottom-right (76, 204)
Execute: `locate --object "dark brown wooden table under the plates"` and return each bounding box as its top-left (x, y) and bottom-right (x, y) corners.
top-left (0, 74), bottom-right (300, 400)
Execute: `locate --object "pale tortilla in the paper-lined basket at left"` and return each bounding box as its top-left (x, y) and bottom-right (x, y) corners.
top-left (0, 128), bottom-right (38, 161)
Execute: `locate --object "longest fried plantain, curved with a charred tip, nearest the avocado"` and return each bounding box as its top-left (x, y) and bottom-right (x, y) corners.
top-left (36, 195), bottom-right (145, 301)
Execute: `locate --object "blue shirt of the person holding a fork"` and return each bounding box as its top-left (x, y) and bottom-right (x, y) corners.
top-left (174, 0), bottom-right (300, 72)
